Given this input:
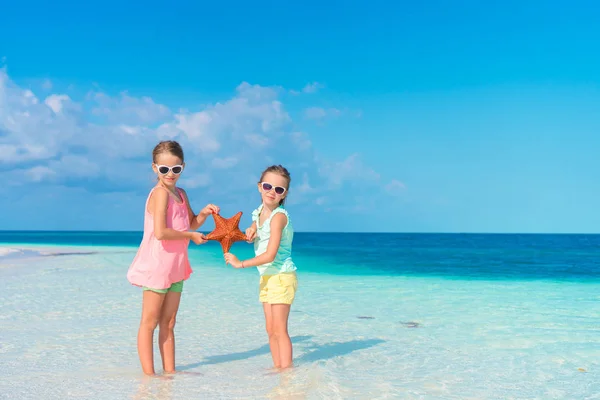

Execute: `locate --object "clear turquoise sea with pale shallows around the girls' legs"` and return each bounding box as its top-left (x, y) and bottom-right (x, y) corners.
top-left (0, 231), bottom-right (600, 400)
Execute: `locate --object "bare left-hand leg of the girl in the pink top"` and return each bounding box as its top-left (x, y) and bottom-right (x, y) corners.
top-left (138, 290), bottom-right (165, 375)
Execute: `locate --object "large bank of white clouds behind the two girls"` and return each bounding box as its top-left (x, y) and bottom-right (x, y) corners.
top-left (0, 69), bottom-right (404, 216)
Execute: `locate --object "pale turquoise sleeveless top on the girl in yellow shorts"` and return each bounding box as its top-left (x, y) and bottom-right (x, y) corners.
top-left (252, 204), bottom-right (296, 275)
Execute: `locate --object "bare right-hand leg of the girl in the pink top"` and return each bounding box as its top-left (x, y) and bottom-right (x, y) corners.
top-left (158, 292), bottom-right (181, 373)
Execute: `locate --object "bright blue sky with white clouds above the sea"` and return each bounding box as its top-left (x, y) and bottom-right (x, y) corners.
top-left (0, 1), bottom-right (600, 233)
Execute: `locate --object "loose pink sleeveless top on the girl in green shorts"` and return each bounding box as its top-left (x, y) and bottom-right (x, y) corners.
top-left (127, 187), bottom-right (192, 289)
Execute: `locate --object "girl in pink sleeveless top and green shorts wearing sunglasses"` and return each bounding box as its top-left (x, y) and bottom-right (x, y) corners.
top-left (127, 141), bottom-right (219, 375)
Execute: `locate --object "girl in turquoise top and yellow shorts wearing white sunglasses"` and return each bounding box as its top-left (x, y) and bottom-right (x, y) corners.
top-left (225, 165), bottom-right (298, 368)
